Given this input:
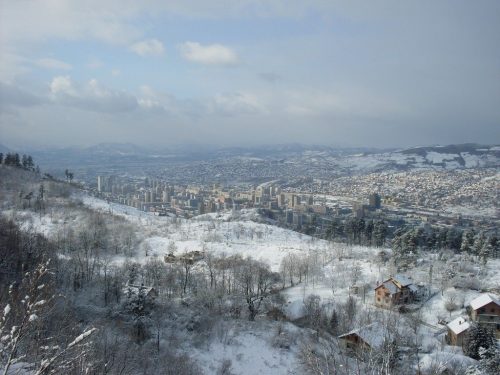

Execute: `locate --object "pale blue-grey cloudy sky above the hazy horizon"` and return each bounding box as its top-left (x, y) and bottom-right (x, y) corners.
top-left (0, 0), bottom-right (500, 147)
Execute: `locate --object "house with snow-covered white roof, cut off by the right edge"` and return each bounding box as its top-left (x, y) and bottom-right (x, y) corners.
top-left (468, 293), bottom-right (500, 339)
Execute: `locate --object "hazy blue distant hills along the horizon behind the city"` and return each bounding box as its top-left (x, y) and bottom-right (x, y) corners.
top-left (5, 143), bottom-right (500, 174)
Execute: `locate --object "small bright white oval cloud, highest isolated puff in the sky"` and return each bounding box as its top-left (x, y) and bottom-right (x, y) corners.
top-left (180, 42), bottom-right (239, 65)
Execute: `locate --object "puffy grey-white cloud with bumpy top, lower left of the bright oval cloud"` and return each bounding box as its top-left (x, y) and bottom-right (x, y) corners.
top-left (50, 76), bottom-right (138, 113)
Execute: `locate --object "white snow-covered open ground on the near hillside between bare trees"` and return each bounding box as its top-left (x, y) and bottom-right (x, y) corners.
top-left (4, 195), bottom-right (500, 374)
